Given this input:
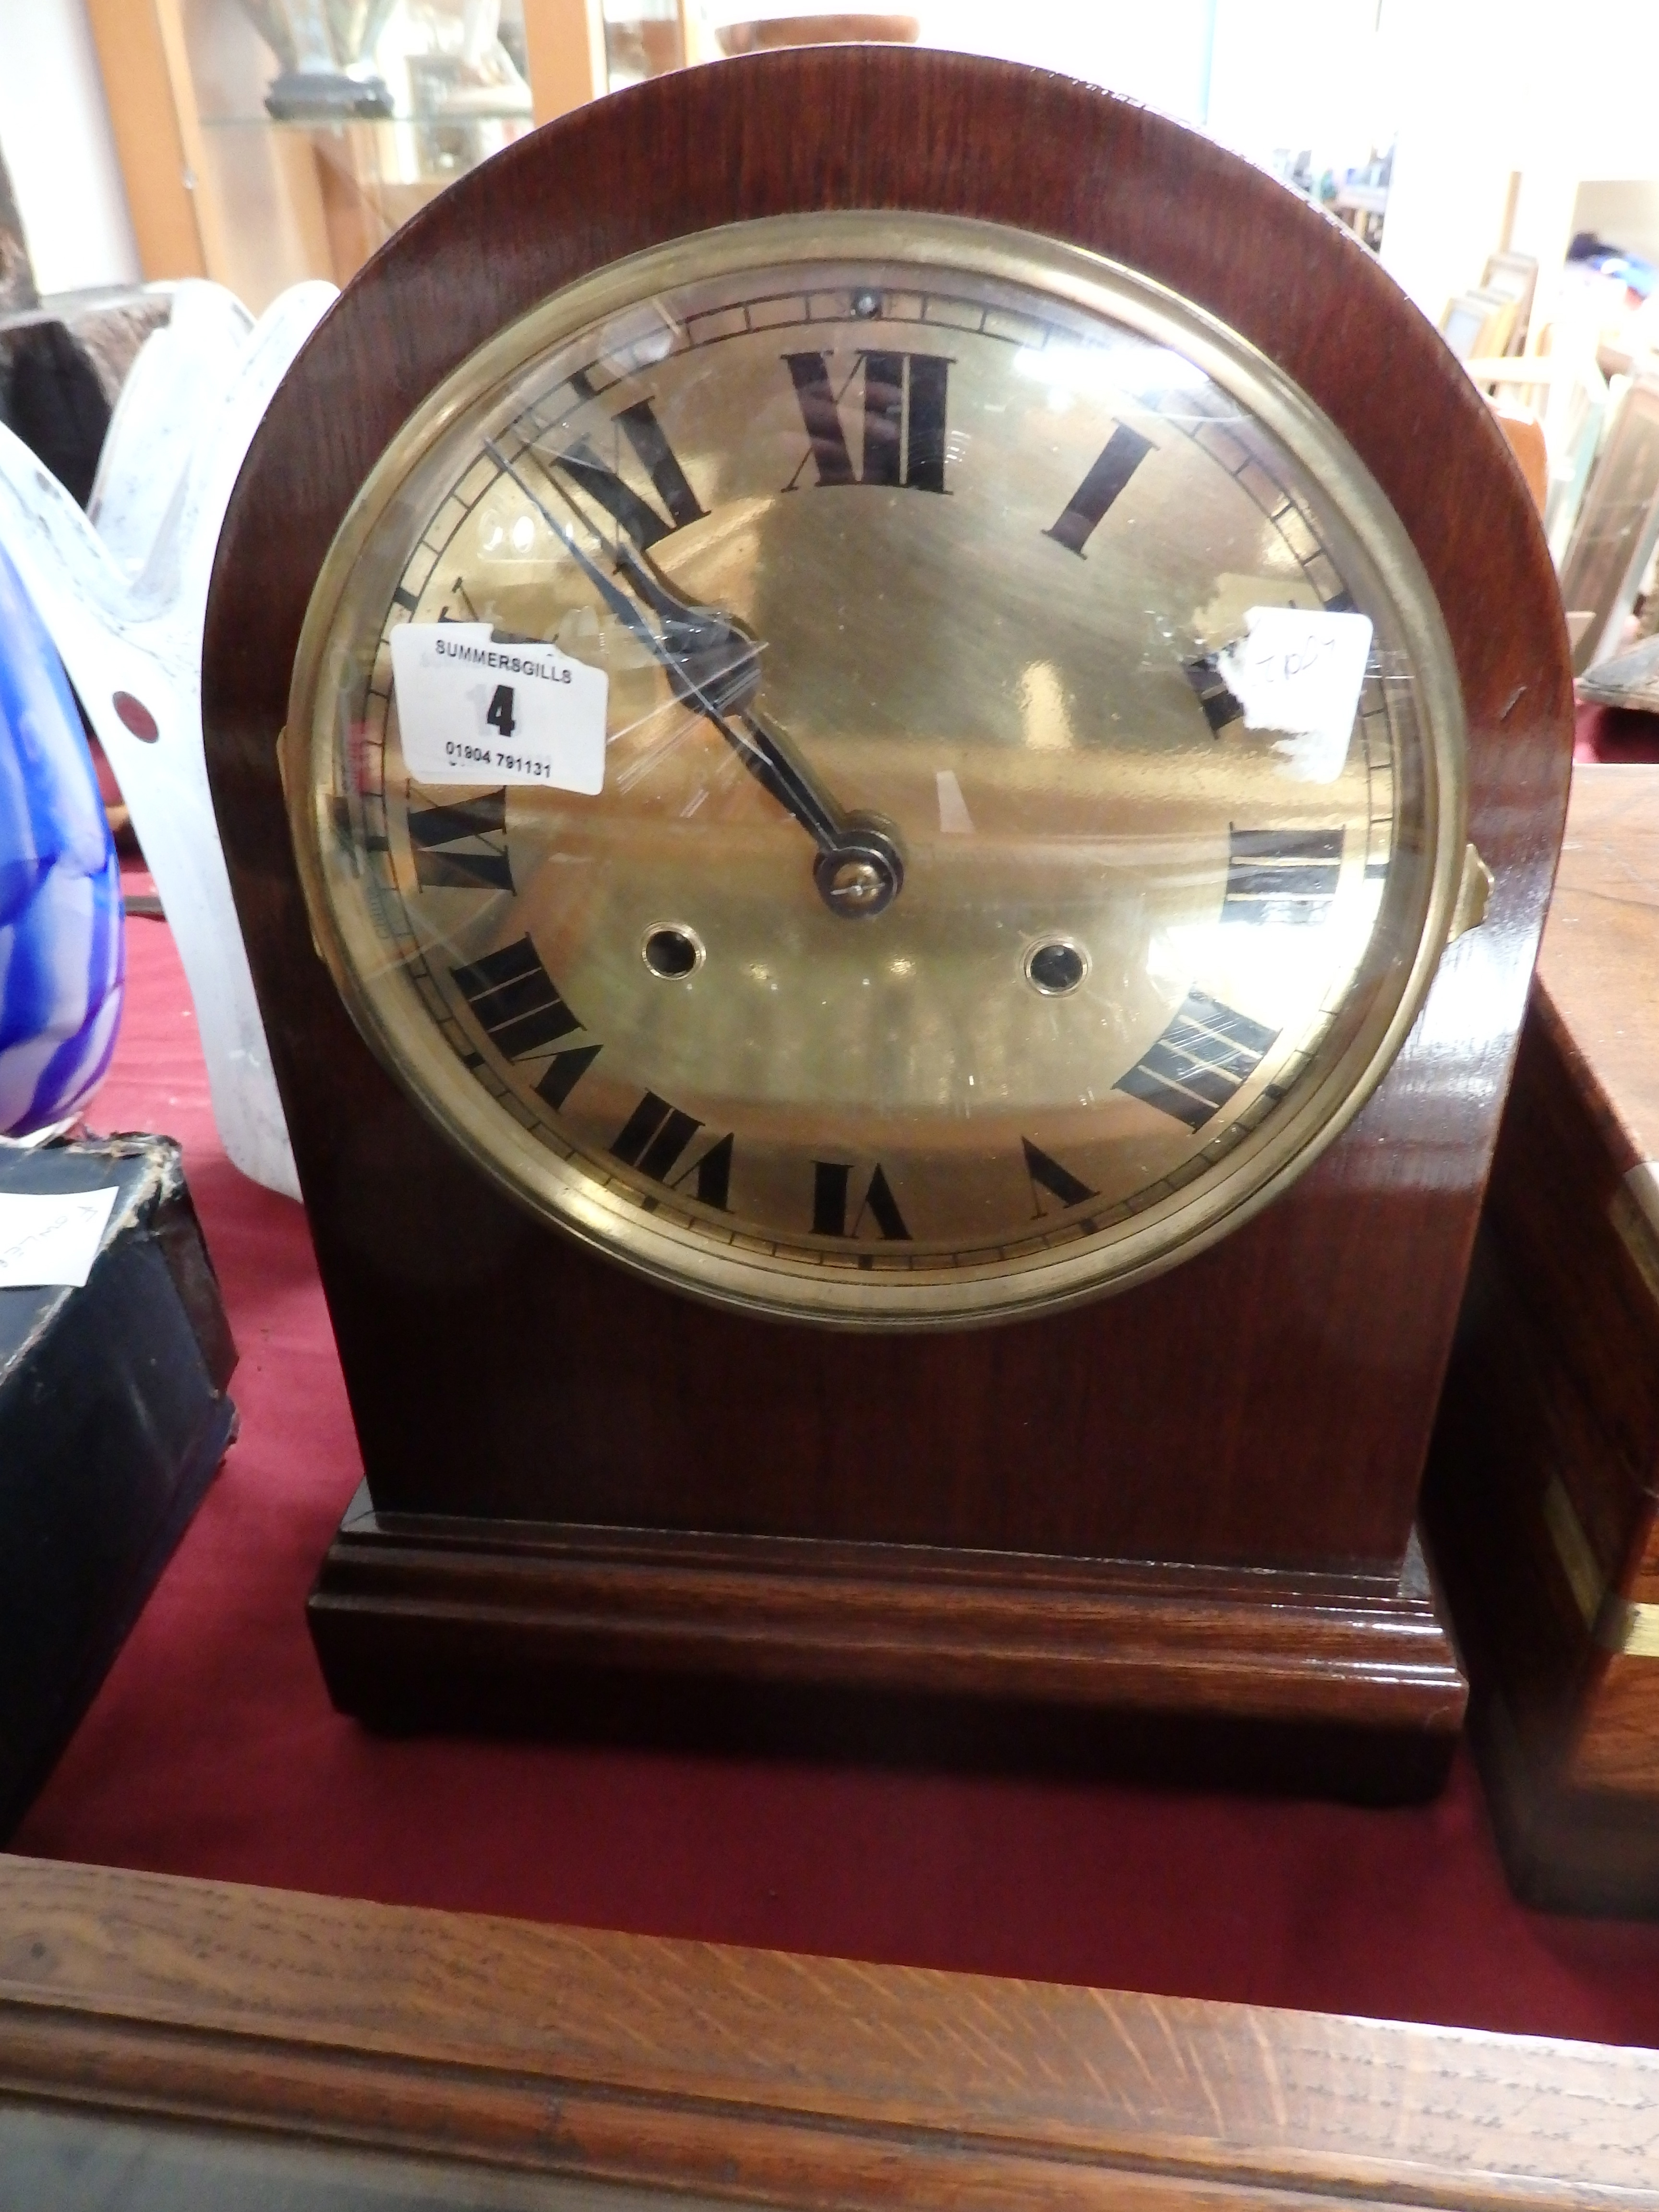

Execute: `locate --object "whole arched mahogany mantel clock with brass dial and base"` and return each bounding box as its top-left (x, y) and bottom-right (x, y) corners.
top-left (204, 48), bottom-right (1571, 1794)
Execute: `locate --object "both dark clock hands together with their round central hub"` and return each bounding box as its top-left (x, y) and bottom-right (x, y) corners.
top-left (484, 438), bottom-right (905, 920)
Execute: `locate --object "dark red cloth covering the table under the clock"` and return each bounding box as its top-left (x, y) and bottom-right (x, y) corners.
top-left (15, 871), bottom-right (1659, 2044)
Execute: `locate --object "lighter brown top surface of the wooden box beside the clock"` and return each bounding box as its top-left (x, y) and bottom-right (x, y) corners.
top-left (1535, 765), bottom-right (1659, 1172)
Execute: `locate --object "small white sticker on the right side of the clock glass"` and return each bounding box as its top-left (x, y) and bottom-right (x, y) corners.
top-left (1216, 606), bottom-right (1371, 783)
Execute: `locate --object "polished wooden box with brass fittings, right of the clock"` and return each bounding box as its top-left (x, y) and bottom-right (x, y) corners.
top-left (1429, 765), bottom-right (1659, 1913)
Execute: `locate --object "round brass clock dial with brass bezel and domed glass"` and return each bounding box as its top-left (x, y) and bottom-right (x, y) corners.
top-left (285, 215), bottom-right (1462, 1325)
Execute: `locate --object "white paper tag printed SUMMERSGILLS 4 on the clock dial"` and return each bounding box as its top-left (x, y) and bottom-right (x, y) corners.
top-left (392, 622), bottom-right (611, 796)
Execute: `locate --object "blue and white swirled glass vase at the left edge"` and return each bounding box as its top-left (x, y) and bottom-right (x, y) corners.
top-left (0, 535), bottom-right (126, 1137)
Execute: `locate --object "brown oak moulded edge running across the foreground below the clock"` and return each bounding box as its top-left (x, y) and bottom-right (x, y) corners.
top-left (0, 1856), bottom-right (1659, 2212)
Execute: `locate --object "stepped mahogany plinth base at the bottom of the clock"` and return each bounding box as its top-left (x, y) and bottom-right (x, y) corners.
top-left (310, 1484), bottom-right (1467, 1801)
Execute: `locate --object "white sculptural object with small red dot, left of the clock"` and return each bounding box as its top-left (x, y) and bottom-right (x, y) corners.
top-left (0, 283), bottom-right (336, 1197)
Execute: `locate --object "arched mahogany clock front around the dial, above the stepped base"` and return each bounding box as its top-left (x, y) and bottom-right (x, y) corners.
top-left (204, 48), bottom-right (1571, 1769)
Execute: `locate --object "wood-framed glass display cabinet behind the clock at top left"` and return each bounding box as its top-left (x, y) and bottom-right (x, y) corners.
top-left (88, 0), bottom-right (624, 312)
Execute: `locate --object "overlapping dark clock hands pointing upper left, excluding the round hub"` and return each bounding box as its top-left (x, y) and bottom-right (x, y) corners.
top-left (484, 440), bottom-right (849, 854)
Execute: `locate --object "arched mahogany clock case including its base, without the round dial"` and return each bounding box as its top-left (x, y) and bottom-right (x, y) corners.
top-left (204, 48), bottom-right (1571, 1794)
